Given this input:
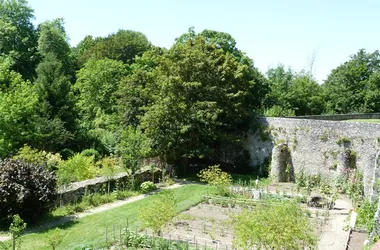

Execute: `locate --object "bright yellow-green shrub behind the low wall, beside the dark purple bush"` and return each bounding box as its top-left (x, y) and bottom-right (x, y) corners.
top-left (57, 154), bottom-right (96, 185)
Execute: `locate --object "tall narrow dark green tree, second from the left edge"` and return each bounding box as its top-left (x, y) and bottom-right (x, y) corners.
top-left (31, 19), bottom-right (76, 151)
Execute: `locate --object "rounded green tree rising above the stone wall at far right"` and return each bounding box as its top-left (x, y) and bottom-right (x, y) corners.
top-left (323, 49), bottom-right (380, 113)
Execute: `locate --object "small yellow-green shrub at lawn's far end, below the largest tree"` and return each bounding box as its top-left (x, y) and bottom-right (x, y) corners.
top-left (198, 165), bottom-right (232, 196)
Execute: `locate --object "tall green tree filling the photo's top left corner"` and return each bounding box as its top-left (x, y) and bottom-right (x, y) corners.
top-left (0, 0), bottom-right (40, 80)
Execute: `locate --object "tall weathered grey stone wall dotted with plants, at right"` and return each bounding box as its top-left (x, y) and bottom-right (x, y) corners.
top-left (246, 118), bottom-right (380, 196)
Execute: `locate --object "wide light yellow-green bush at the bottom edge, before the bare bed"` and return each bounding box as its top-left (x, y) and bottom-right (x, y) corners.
top-left (233, 201), bottom-right (317, 249)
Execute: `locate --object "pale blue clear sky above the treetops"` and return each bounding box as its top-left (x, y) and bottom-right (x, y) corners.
top-left (28, 0), bottom-right (380, 83)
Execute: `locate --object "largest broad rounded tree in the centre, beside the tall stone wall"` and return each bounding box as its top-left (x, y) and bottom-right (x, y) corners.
top-left (140, 30), bottom-right (264, 162)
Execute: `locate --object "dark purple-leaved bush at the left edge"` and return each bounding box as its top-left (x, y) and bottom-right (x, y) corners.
top-left (0, 159), bottom-right (57, 220)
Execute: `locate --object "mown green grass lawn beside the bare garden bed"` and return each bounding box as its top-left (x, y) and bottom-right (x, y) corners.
top-left (16, 184), bottom-right (209, 250)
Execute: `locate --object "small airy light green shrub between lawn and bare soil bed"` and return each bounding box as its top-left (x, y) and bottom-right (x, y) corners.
top-left (140, 190), bottom-right (177, 235)
